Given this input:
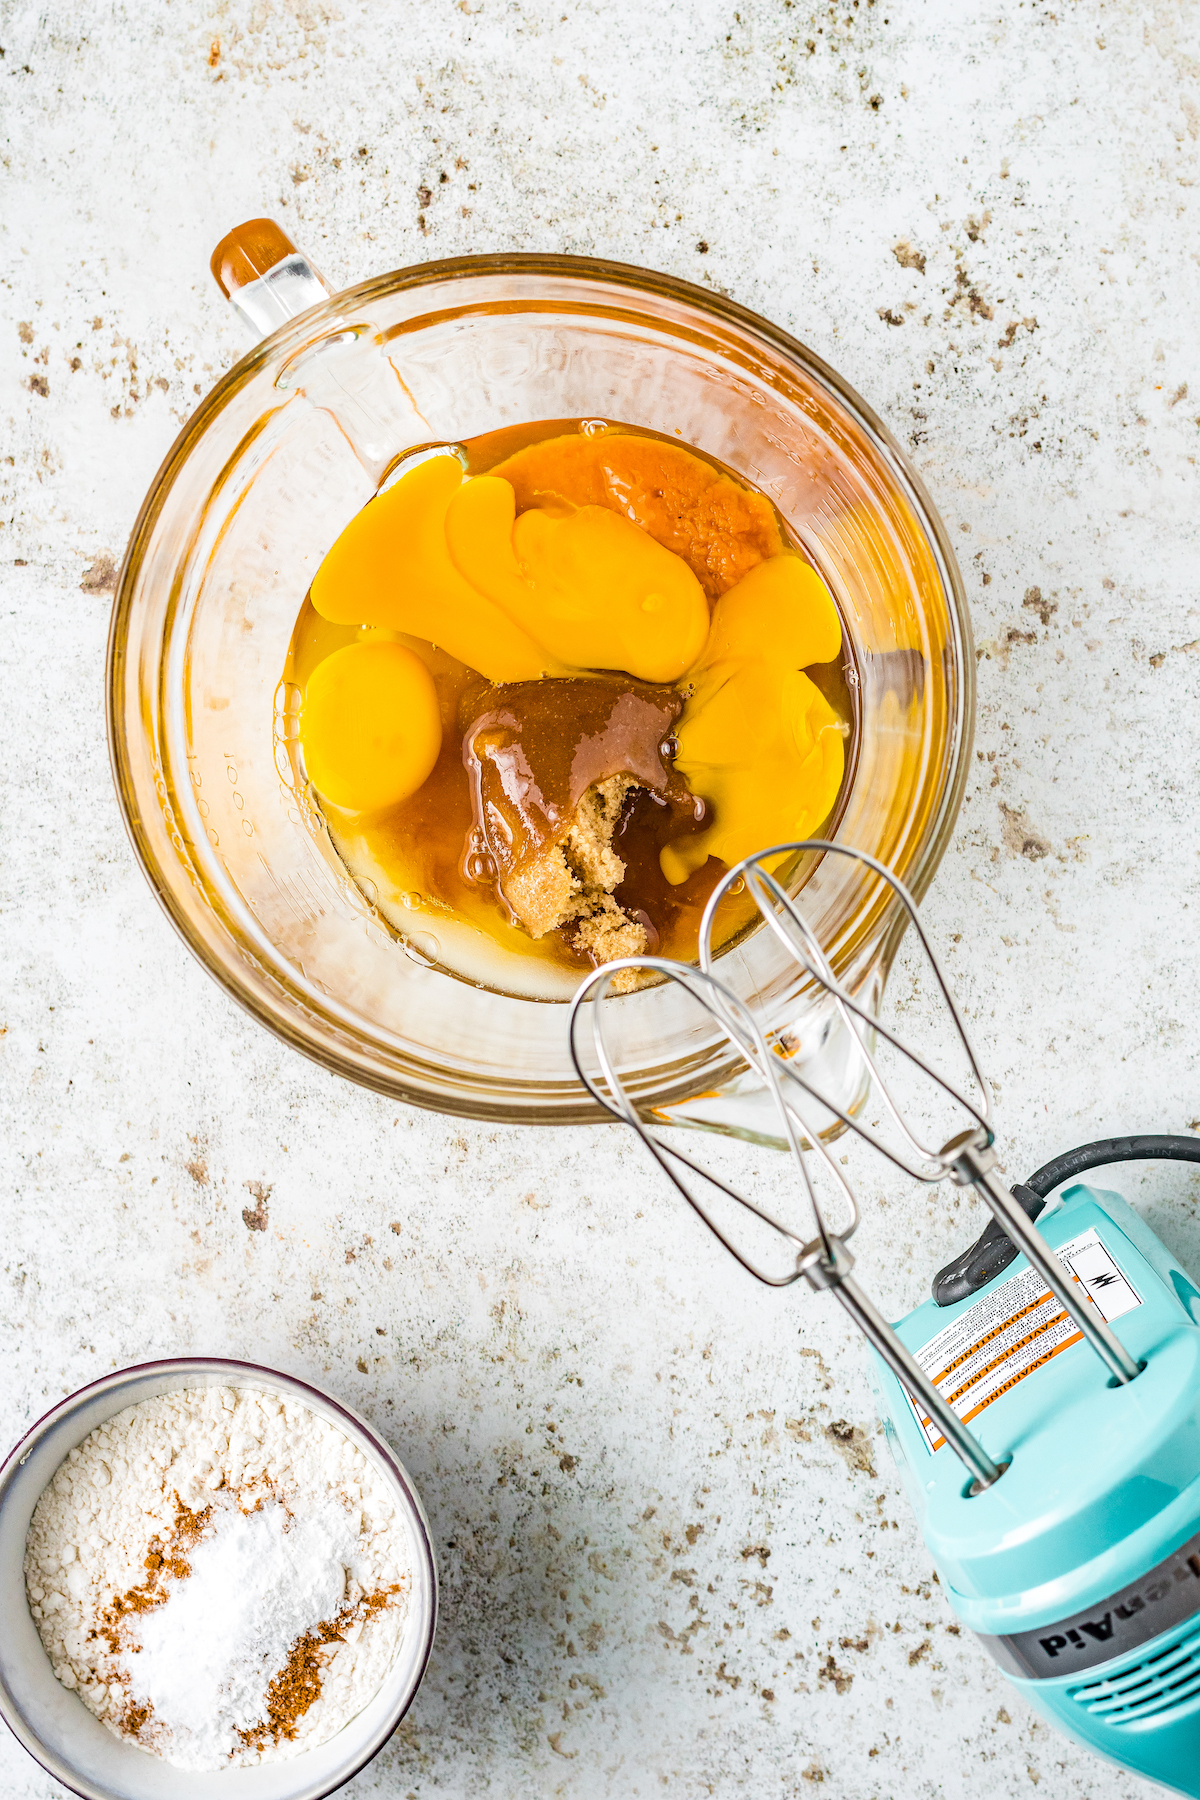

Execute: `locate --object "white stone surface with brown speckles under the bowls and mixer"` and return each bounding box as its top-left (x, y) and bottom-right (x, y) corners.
top-left (0, 0), bottom-right (1200, 1800)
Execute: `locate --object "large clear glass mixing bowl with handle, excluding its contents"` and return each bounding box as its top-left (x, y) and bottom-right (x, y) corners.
top-left (108, 226), bottom-right (975, 1139)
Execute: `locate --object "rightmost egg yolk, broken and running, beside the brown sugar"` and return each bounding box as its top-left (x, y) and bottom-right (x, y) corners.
top-left (658, 554), bottom-right (844, 886)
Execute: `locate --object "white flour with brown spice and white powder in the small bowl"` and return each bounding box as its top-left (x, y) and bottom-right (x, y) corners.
top-left (25, 1388), bottom-right (408, 1769)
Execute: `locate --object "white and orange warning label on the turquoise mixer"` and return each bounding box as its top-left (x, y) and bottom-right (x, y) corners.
top-left (910, 1229), bottom-right (1142, 1451)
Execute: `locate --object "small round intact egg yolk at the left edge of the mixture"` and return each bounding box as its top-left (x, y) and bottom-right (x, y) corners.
top-left (300, 639), bottom-right (441, 812)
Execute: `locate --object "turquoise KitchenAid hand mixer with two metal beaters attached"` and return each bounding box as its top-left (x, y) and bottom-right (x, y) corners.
top-left (570, 839), bottom-right (1200, 1800)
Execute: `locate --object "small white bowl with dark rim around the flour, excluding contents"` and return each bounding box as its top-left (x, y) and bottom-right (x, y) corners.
top-left (0, 1357), bottom-right (437, 1800)
